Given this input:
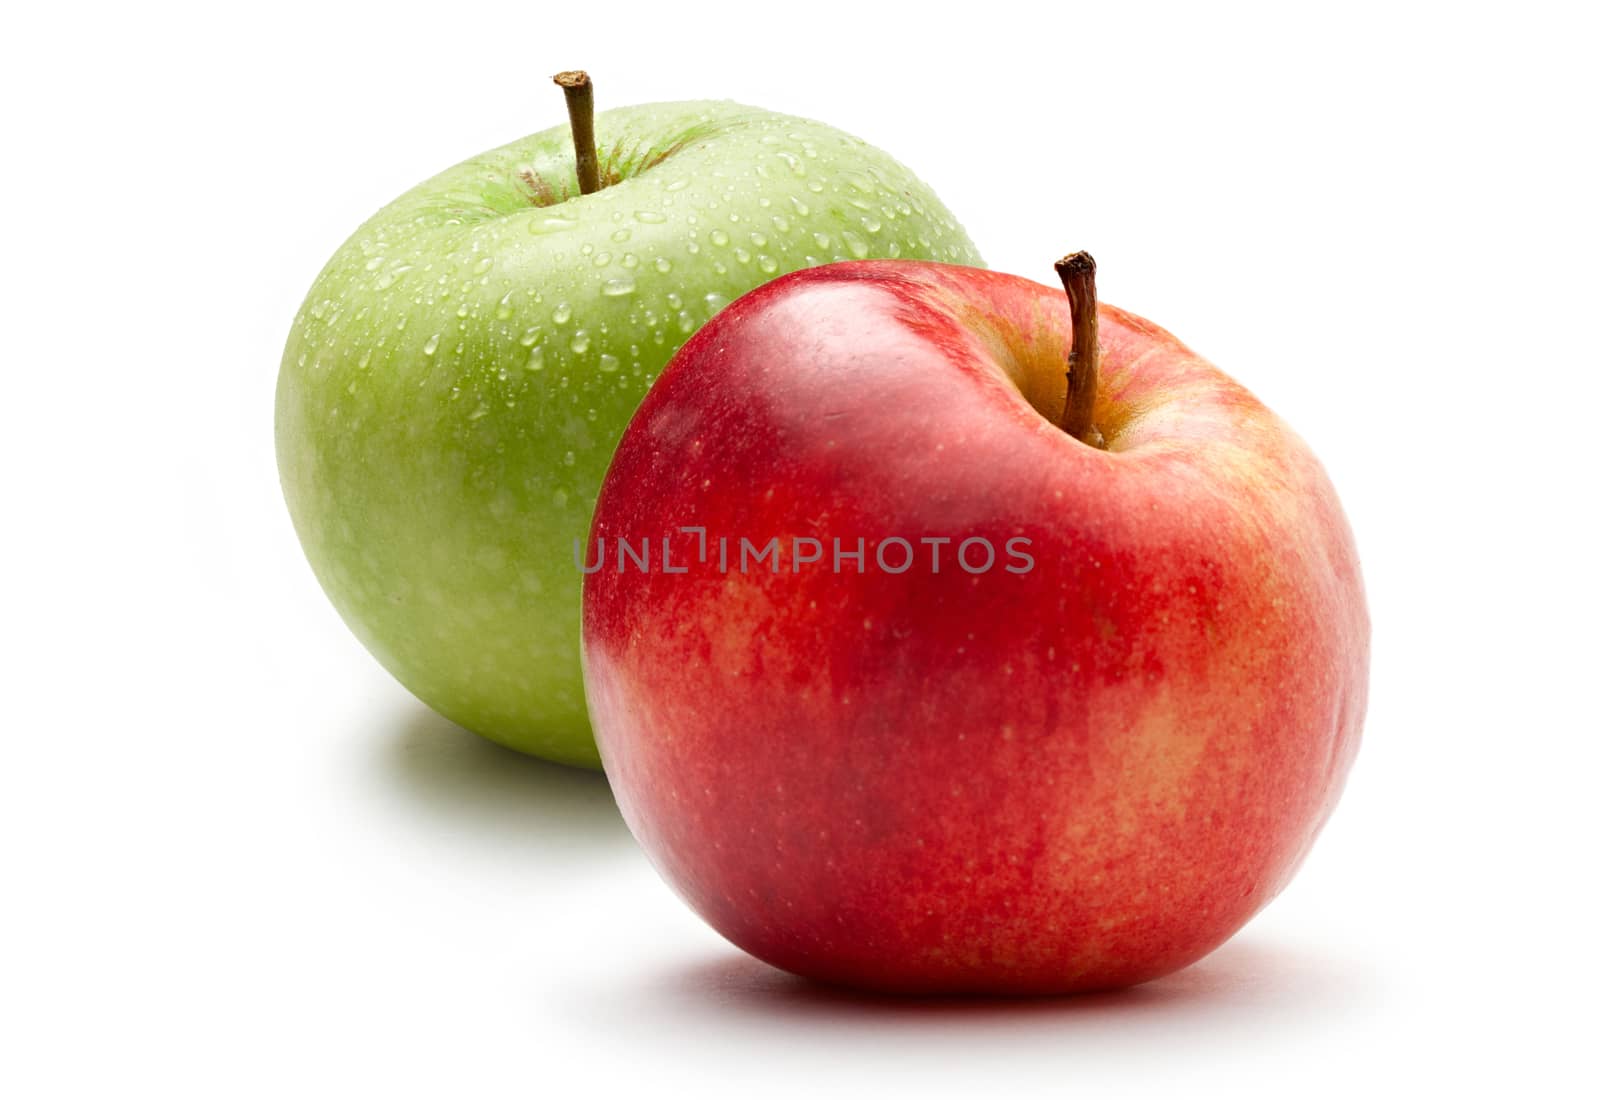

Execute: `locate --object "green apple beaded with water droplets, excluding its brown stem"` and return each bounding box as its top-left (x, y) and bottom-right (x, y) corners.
top-left (277, 92), bottom-right (981, 767)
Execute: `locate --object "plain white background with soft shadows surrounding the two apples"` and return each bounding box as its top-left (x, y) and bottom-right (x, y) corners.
top-left (0, 0), bottom-right (1600, 1097)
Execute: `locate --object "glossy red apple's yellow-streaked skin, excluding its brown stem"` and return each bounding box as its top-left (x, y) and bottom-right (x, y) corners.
top-left (584, 262), bottom-right (1370, 994)
